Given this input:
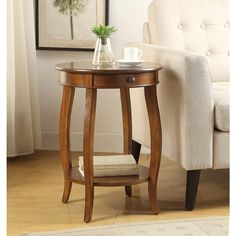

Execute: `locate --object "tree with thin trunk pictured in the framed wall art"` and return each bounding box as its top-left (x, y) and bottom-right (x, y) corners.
top-left (53, 0), bottom-right (88, 40)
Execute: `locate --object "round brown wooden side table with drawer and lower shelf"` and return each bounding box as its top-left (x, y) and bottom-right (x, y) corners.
top-left (56, 62), bottom-right (162, 222)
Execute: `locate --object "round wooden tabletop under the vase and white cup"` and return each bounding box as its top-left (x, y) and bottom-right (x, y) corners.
top-left (56, 61), bottom-right (162, 74)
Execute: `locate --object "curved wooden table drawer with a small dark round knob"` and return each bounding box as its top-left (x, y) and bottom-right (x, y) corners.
top-left (93, 72), bottom-right (158, 88)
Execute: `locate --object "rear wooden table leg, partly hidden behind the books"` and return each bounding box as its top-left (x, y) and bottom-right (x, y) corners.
top-left (120, 88), bottom-right (132, 197)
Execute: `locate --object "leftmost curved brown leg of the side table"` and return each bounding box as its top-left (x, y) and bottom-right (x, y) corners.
top-left (60, 86), bottom-right (75, 203)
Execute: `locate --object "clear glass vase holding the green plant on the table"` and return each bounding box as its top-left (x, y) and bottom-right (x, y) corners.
top-left (93, 38), bottom-right (115, 66)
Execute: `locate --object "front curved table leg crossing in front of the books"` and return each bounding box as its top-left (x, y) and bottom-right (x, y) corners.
top-left (83, 89), bottom-right (97, 223)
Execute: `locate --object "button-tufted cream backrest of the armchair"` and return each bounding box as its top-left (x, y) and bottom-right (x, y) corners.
top-left (148, 0), bottom-right (229, 82)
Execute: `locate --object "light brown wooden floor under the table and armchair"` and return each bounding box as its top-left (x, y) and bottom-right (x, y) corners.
top-left (7, 151), bottom-right (229, 236)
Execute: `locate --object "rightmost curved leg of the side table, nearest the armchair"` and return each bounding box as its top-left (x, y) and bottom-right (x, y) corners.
top-left (144, 85), bottom-right (162, 214)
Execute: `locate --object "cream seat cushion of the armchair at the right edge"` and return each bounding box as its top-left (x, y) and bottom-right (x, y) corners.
top-left (212, 82), bottom-right (230, 132)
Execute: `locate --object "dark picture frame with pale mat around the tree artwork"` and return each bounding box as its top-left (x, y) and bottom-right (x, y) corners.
top-left (35, 0), bottom-right (109, 51)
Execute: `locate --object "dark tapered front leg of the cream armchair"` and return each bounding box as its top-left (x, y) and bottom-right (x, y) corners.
top-left (185, 170), bottom-right (201, 211)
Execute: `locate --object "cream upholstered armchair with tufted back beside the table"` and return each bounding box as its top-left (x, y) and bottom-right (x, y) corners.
top-left (128, 0), bottom-right (230, 210)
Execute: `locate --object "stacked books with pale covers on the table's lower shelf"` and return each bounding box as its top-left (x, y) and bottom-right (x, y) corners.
top-left (79, 155), bottom-right (138, 177)
